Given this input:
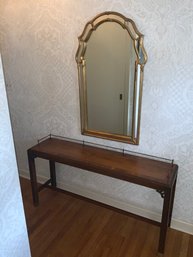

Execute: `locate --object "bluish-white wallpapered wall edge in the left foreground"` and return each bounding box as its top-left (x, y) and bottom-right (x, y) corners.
top-left (0, 55), bottom-right (31, 254)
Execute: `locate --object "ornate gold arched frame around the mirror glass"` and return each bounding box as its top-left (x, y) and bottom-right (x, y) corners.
top-left (76, 12), bottom-right (147, 144)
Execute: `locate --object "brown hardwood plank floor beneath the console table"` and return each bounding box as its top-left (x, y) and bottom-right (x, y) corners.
top-left (21, 179), bottom-right (193, 257)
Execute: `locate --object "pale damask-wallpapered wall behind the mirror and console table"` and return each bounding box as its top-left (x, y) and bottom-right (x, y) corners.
top-left (0, 0), bottom-right (193, 228)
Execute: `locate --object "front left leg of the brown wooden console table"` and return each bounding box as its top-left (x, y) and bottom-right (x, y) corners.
top-left (28, 151), bottom-right (39, 206)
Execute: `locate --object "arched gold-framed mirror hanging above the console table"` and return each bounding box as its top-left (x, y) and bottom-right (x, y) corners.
top-left (76, 12), bottom-right (147, 144)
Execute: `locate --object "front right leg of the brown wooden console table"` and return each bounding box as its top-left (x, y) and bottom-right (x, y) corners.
top-left (158, 189), bottom-right (172, 254)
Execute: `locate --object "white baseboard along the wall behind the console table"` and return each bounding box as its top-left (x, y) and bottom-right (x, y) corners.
top-left (20, 170), bottom-right (193, 235)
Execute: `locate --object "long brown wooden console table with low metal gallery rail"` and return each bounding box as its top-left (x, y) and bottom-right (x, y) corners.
top-left (28, 136), bottom-right (178, 254)
